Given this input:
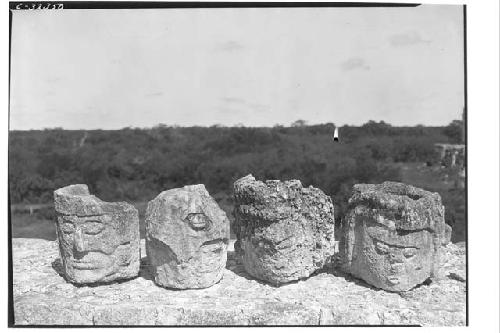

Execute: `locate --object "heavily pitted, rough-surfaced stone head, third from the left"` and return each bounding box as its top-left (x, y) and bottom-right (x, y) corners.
top-left (234, 175), bottom-right (335, 285)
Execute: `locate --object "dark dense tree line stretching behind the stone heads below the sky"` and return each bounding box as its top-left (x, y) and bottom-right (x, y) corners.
top-left (9, 121), bottom-right (456, 222)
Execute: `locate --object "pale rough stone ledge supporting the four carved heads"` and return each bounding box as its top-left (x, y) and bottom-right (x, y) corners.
top-left (12, 238), bottom-right (466, 326)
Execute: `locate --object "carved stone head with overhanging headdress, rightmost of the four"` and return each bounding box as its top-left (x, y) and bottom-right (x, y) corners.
top-left (340, 182), bottom-right (449, 291)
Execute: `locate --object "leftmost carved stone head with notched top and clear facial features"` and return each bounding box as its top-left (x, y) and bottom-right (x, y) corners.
top-left (54, 184), bottom-right (140, 284)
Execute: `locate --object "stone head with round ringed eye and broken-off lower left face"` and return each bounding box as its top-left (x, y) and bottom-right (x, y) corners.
top-left (146, 185), bottom-right (229, 289)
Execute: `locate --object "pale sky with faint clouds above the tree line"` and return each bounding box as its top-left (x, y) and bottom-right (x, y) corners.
top-left (10, 5), bottom-right (464, 129)
